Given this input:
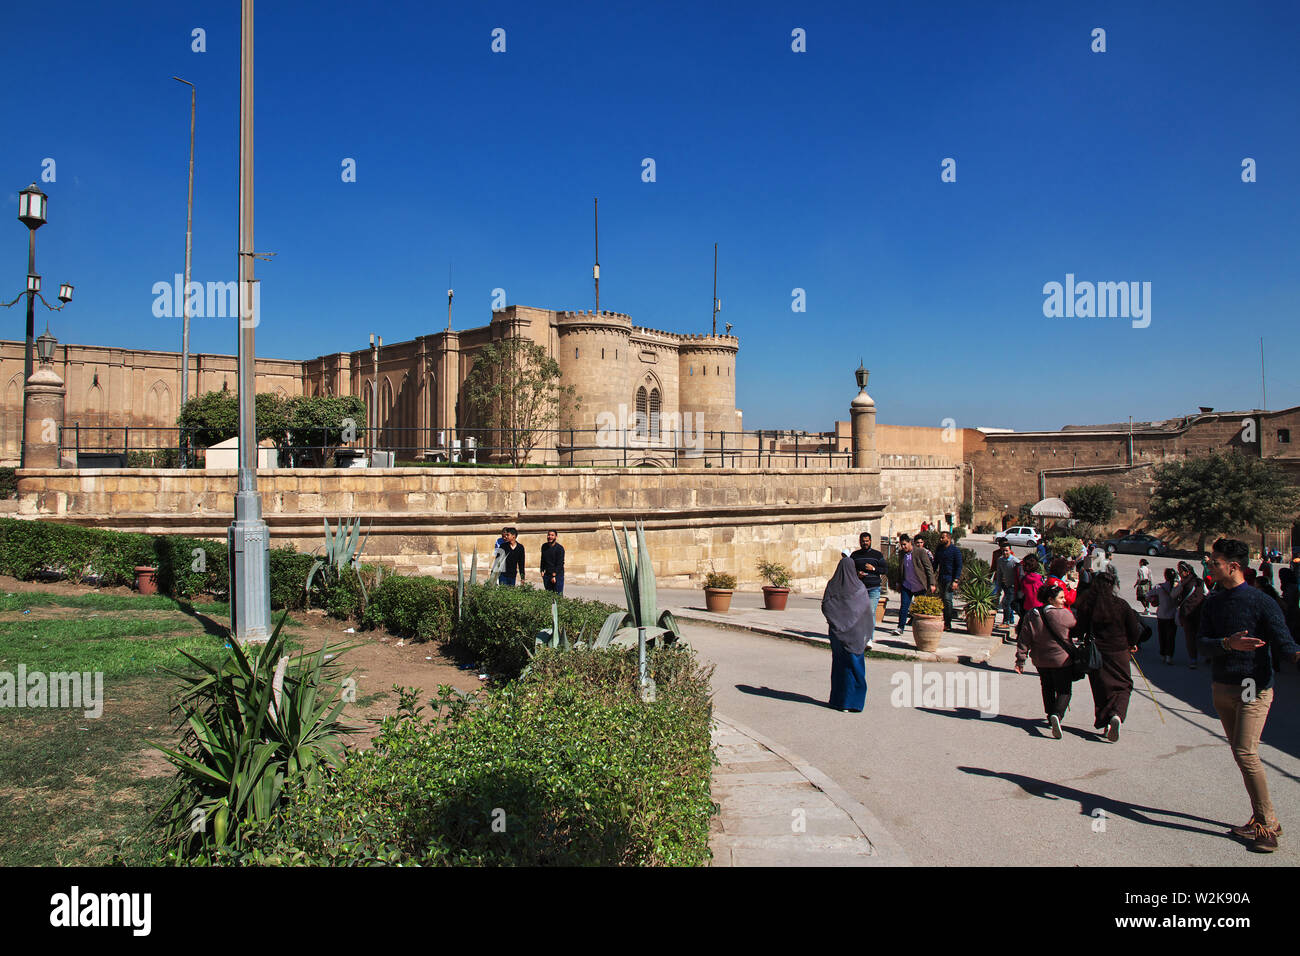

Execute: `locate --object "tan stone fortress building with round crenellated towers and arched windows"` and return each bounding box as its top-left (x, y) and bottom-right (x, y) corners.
top-left (0, 306), bottom-right (741, 464)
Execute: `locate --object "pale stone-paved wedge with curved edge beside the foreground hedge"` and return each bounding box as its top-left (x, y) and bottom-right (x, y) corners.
top-left (710, 711), bottom-right (911, 866)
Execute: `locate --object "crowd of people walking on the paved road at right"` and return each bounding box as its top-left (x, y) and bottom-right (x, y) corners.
top-left (822, 532), bottom-right (1300, 852)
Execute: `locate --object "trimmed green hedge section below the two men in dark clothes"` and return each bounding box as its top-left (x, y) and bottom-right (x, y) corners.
top-left (454, 584), bottom-right (620, 678)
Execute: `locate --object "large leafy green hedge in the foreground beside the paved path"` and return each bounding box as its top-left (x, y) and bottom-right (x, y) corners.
top-left (235, 648), bottom-right (715, 866)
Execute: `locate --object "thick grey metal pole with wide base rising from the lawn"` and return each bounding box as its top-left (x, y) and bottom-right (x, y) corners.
top-left (229, 0), bottom-right (270, 643)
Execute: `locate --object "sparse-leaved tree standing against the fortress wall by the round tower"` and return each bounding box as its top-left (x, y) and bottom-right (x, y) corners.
top-left (465, 338), bottom-right (577, 467)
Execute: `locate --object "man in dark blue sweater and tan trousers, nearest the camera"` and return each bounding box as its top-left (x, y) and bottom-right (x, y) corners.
top-left (1196, 537), bottom-right (1300, 852)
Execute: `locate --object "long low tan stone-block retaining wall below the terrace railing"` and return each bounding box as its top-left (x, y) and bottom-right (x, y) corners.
top-left (18, 468), bottom-right (885, 591)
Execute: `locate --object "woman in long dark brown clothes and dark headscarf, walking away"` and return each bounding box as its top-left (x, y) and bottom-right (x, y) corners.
top-left (1070, 571), bottom-right (1151, 743)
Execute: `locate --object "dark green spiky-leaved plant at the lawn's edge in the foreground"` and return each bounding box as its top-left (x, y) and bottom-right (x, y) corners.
top-left (153, 611), bottom-right (358, 858)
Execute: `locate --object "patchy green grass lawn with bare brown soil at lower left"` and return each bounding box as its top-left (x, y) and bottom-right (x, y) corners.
top-left (0, 592), bottom-right (276, 866)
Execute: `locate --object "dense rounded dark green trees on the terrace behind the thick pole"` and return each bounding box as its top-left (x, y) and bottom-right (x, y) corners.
top-left (177, 392), bottom-right (365, 467)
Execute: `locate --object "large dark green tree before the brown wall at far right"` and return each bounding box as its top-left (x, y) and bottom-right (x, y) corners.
top-left (1147, 453), bottom-right (1300, 551)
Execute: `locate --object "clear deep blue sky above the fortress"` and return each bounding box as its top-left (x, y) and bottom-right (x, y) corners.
top-left (0, 0), bottom-right (1300, 429)
